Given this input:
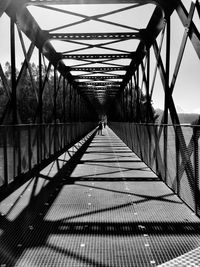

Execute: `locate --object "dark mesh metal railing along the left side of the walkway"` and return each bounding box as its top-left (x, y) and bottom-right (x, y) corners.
top-left (0, 122), bottom-right (95, 194)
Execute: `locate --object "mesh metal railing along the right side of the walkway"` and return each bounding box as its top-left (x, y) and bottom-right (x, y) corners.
top-left (110, 122), bottom-right (200, 219)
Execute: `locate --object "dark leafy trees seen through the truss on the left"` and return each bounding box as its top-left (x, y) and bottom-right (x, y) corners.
top-left (0, 62), bottom-right (63, 124)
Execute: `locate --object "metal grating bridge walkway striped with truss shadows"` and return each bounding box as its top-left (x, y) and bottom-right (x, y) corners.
top-left (0, 127), bottom-right (200, 267)
